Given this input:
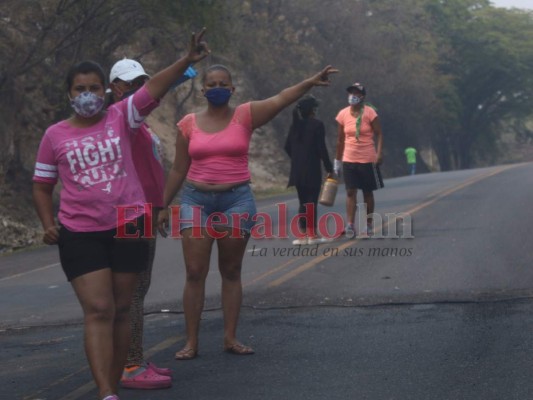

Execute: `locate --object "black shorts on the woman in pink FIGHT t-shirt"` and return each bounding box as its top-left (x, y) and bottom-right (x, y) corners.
top-left (57, 216), bottom-right (149, 282)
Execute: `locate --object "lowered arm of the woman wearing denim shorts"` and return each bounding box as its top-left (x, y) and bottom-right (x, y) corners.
top-left (158, 128), bottom-right (191, 237)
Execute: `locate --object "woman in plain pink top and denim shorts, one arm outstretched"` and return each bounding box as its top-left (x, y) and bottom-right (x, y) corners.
top-left (159, 65), bottom-right (337, 360)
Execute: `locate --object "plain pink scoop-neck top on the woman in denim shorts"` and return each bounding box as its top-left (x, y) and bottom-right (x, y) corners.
top-left (178, 103), bottom-right (253, 184)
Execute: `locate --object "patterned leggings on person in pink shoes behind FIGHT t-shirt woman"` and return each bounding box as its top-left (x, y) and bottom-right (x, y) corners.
top-left (126, 239), bottom-right (156, 367)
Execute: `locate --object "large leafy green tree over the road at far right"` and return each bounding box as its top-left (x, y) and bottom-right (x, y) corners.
top-left (428, 0), bottom-right (533, 168)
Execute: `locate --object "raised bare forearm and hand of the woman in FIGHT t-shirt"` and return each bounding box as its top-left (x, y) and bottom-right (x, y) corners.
top-left (146, 28), bottom-right (210, 99)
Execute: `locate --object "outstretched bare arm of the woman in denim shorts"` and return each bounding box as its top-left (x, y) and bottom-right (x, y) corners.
top-left (251, 65), bottom-right (339, 129)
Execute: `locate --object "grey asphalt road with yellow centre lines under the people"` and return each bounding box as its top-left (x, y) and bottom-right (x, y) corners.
top-left (0, 163), bottom-right (533, 400)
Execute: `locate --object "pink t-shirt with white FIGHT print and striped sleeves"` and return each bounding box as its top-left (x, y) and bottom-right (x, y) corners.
top-left (33, 87), bottom-right (159, 232)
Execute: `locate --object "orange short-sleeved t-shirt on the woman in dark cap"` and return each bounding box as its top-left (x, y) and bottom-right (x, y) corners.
top-left (335, 106), bottom-right (378, 163)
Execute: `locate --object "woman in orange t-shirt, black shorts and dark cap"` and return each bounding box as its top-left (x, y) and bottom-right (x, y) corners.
top-left (334, 83), bottom-right (383, 238)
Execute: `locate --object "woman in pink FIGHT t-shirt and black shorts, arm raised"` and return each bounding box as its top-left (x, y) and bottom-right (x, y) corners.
top-left (29, 30), bottom-right (209, 400)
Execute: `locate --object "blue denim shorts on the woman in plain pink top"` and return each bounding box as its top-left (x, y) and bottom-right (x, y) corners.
top-left (171, 182), bottom-right (257, 236)
